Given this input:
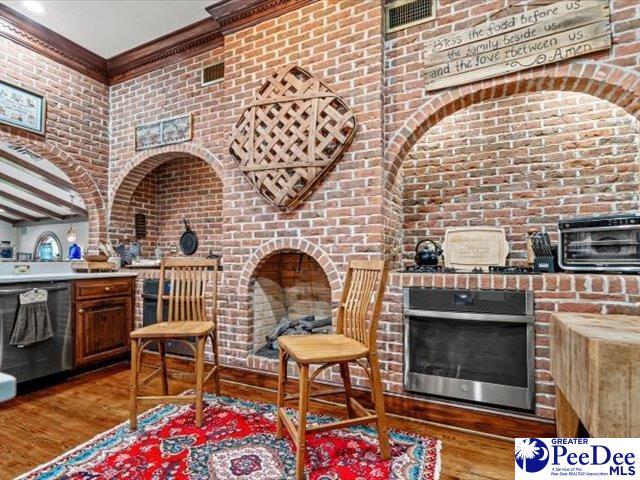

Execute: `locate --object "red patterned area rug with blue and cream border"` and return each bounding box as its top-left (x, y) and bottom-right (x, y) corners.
top-left (20, 395), bottom-right (440, 480)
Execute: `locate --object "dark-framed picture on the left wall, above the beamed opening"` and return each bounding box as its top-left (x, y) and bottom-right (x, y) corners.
top-left (0, 80), bottom-right (47, 135)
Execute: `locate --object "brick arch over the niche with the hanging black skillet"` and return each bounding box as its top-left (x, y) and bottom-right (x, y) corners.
top-left (108, 143), bottom-right (224, 240)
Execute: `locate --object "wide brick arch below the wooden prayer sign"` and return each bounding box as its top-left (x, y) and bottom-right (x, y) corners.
top-left (385, 61), bottom-right (640, 192)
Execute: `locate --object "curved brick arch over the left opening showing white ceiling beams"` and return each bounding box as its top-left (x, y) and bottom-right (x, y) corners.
top-left (0, 130), bottom-right (106, 246)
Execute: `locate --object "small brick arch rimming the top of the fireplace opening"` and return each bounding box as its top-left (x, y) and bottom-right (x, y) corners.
top-left (238, 237), bottom-right (342, 296)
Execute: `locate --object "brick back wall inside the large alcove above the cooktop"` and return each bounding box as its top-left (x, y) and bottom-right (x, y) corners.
top-left (403, 92), bottom-right (640, 264)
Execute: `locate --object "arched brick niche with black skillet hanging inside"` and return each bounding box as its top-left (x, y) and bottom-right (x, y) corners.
top-left (109, 148), bottom-right (223, 257)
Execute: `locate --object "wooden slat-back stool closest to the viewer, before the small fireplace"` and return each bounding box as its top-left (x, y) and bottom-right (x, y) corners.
top-left (276, 260), bottom-right (391, 480)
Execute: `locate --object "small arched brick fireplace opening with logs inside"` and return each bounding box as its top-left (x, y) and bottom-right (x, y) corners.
top-left (251, 250), bottom-right (331, 358)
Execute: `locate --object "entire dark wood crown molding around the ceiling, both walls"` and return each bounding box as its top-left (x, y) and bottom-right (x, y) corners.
top-left (0, 0), bottom-right (317, 85)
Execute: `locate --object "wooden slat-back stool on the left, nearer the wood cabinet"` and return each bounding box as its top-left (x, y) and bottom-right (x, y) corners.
top-left (129, 258), bottom-right (220, 430)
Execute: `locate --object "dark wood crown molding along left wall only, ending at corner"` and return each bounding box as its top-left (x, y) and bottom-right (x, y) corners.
top-left (0, 4), bottom-right (109, 83)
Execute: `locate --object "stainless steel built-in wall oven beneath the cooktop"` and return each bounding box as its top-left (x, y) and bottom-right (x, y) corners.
top-left (404, 287), bottom-right (535, 410)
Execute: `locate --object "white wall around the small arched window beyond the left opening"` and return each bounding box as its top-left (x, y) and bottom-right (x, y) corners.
top-left (0, 221), bottom-right (89, 259)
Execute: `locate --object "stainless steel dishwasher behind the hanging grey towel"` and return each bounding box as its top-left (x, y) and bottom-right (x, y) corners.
top-left (0, 282), bottom-right (73, 383)
